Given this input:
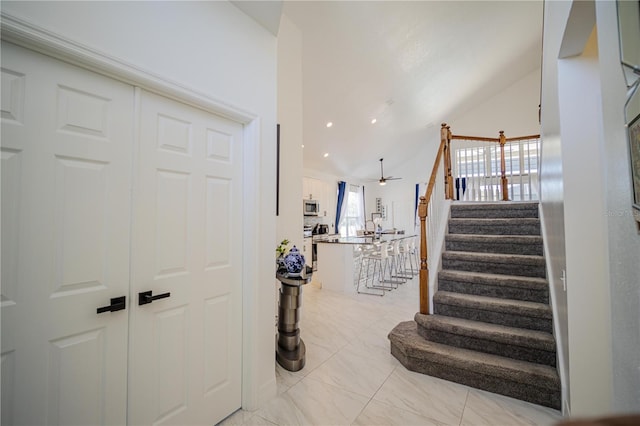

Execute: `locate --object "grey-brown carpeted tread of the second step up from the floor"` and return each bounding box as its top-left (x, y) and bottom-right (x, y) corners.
top-left (415, 313), bottom-right (556, 352)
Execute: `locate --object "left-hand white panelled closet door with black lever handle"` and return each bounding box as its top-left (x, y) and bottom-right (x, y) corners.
top-left (1, 43), bottom-right (134, 425)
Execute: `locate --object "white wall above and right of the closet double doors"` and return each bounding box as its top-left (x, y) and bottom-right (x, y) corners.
top-left (2, 1), bottom-right (276, 409)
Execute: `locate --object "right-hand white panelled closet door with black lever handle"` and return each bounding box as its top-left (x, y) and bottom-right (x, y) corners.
top-left (129, 91), bottom-right (243, 425)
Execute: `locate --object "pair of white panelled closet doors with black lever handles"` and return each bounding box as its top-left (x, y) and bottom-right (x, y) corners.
top-left (0, 43), bottom-right (242, 425)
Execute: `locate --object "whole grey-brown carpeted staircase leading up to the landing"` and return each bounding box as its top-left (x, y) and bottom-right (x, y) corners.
top-left (389, 202), bottom-right (561, 409)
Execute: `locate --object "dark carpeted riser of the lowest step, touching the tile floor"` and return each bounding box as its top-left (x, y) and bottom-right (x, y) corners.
top-left (391, 342), bottom-right (561, 410)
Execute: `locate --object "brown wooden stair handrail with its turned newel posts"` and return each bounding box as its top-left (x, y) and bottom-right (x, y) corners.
top-left (418, 123), bottom-right (540, 315)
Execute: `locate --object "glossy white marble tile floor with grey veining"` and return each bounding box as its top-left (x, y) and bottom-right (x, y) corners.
top-left (220, 278), bottom-right (562, 426)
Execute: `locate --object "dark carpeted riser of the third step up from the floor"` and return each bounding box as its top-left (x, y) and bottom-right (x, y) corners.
top-left (433, 302), bottom-right (553, 333)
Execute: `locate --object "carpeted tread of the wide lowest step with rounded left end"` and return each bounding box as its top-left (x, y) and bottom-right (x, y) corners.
top-left (389, 321), bottom-right (560, 390)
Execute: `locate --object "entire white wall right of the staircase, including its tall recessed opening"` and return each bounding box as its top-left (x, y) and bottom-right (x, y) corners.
top-left (541, 2), bottom-right (640, 416)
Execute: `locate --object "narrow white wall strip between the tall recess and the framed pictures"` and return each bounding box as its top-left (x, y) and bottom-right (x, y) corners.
top-left (595, 2), bottom-right (640, 413)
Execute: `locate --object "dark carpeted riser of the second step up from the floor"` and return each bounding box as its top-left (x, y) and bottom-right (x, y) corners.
top-left (418, 325), bottom-right (556, 367)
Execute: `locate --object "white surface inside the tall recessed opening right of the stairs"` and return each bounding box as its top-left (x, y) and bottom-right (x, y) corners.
top-left (558, 25), bottom-right (612, 415)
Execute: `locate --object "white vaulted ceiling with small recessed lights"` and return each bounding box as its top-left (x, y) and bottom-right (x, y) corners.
top-left (282, 1), bottom-right (543, 179)
